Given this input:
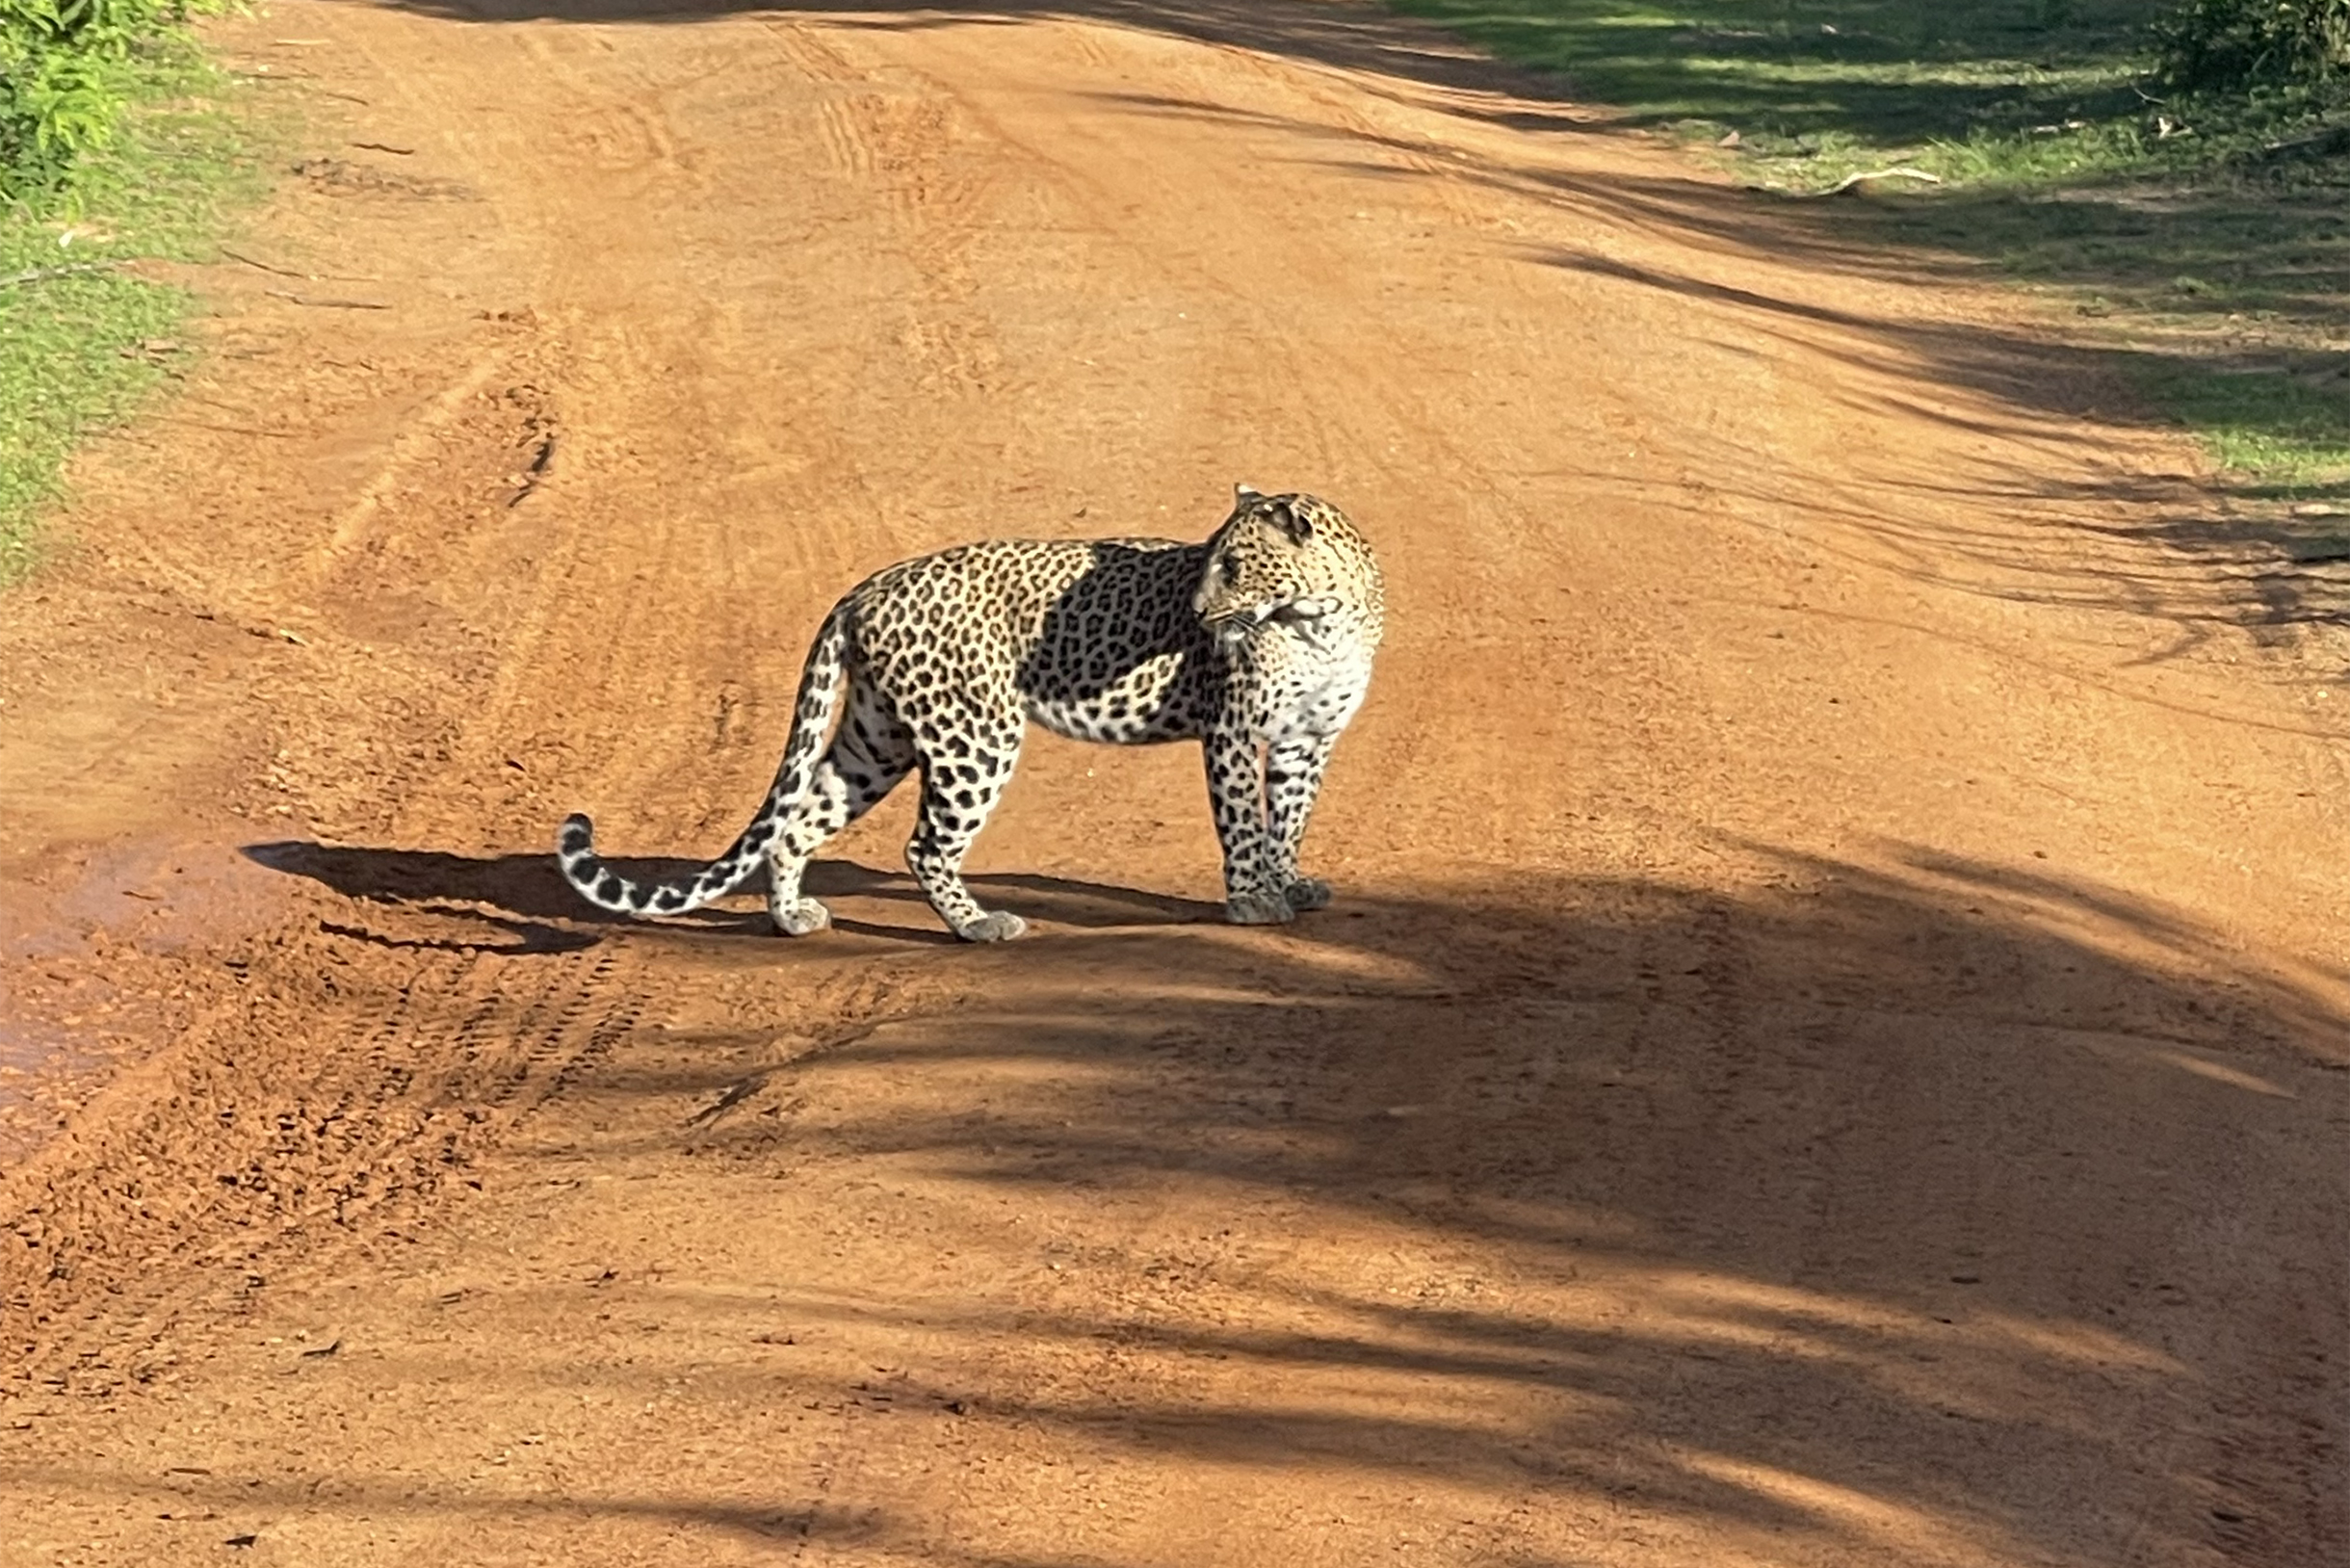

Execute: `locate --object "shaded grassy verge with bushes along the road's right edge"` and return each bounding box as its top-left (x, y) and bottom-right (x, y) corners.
top-left (1394, 0), bottom-right (2350, 496)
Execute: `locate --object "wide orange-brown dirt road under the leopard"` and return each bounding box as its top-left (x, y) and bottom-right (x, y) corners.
top-left (0, 0), bottom-right (2350, 1568)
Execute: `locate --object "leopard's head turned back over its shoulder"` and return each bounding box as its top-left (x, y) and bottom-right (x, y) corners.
top-left (1191, 484), bottom-right (1382, 641)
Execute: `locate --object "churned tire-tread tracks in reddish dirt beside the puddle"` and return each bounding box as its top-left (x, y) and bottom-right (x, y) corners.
top-left (0, 919), bottom-right (644, 1394)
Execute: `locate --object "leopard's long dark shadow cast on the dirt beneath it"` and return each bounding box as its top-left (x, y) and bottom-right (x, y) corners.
top-left (245, 839), bottom-right (1224, 950)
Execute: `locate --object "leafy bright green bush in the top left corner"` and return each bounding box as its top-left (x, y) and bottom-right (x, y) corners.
top-left (0, 0), bottom-right (188, 196)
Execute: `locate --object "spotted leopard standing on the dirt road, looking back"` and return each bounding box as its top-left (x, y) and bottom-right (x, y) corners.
top-left (555, 484), bottom-right (1387, 943)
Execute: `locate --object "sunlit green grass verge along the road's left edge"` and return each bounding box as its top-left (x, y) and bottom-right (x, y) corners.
top-left (0, 54), bottom-right (261, 586)
